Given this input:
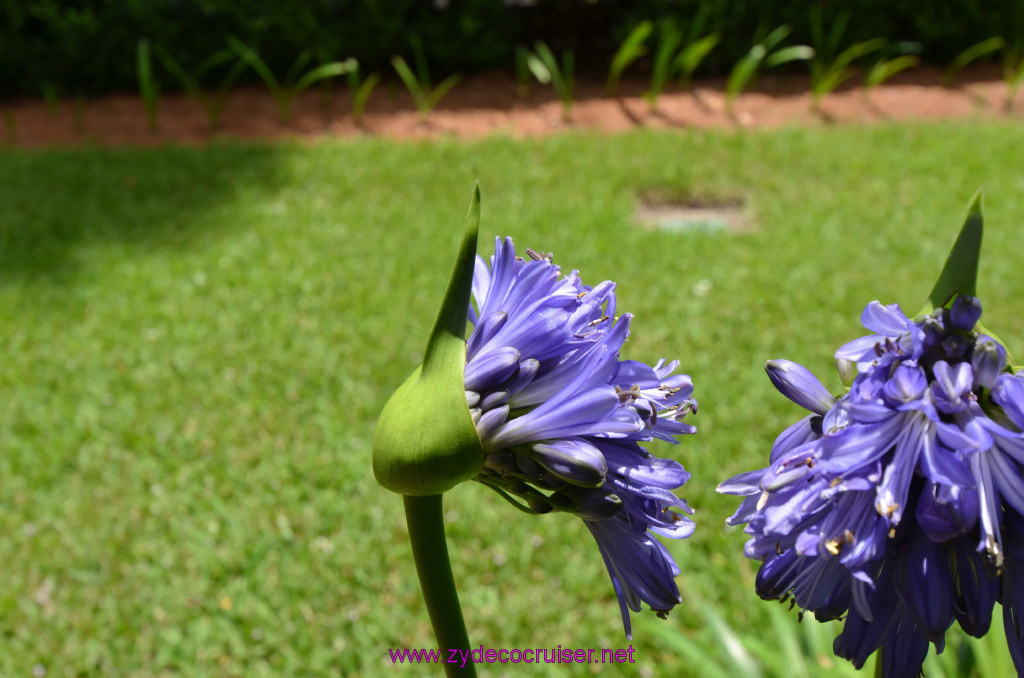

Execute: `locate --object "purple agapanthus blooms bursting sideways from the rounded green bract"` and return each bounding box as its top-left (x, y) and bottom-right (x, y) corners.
top-left (464, 239), bottom-right (696, 636)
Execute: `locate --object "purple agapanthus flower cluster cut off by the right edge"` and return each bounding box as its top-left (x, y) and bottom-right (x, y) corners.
top-left (719, 296), bottom-right (1024, 678)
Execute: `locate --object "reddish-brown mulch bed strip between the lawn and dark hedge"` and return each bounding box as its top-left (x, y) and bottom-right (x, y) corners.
top-left (0, 69), bottom-right (1020, 147)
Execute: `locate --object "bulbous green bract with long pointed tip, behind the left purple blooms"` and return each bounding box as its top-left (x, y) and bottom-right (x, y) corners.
top-left (374, 184), bottom-right (483, 497)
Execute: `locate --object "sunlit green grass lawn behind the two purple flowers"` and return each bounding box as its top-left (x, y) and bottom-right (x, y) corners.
top-left (0, 122), bottom-right (1024, 677)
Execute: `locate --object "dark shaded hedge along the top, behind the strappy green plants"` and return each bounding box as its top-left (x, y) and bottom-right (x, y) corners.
top-left (0, 0), bottom-right (1024, 96)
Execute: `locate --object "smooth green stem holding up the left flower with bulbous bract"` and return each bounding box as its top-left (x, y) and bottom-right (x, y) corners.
top-left (403, 495), bottom-right (476, 678)
